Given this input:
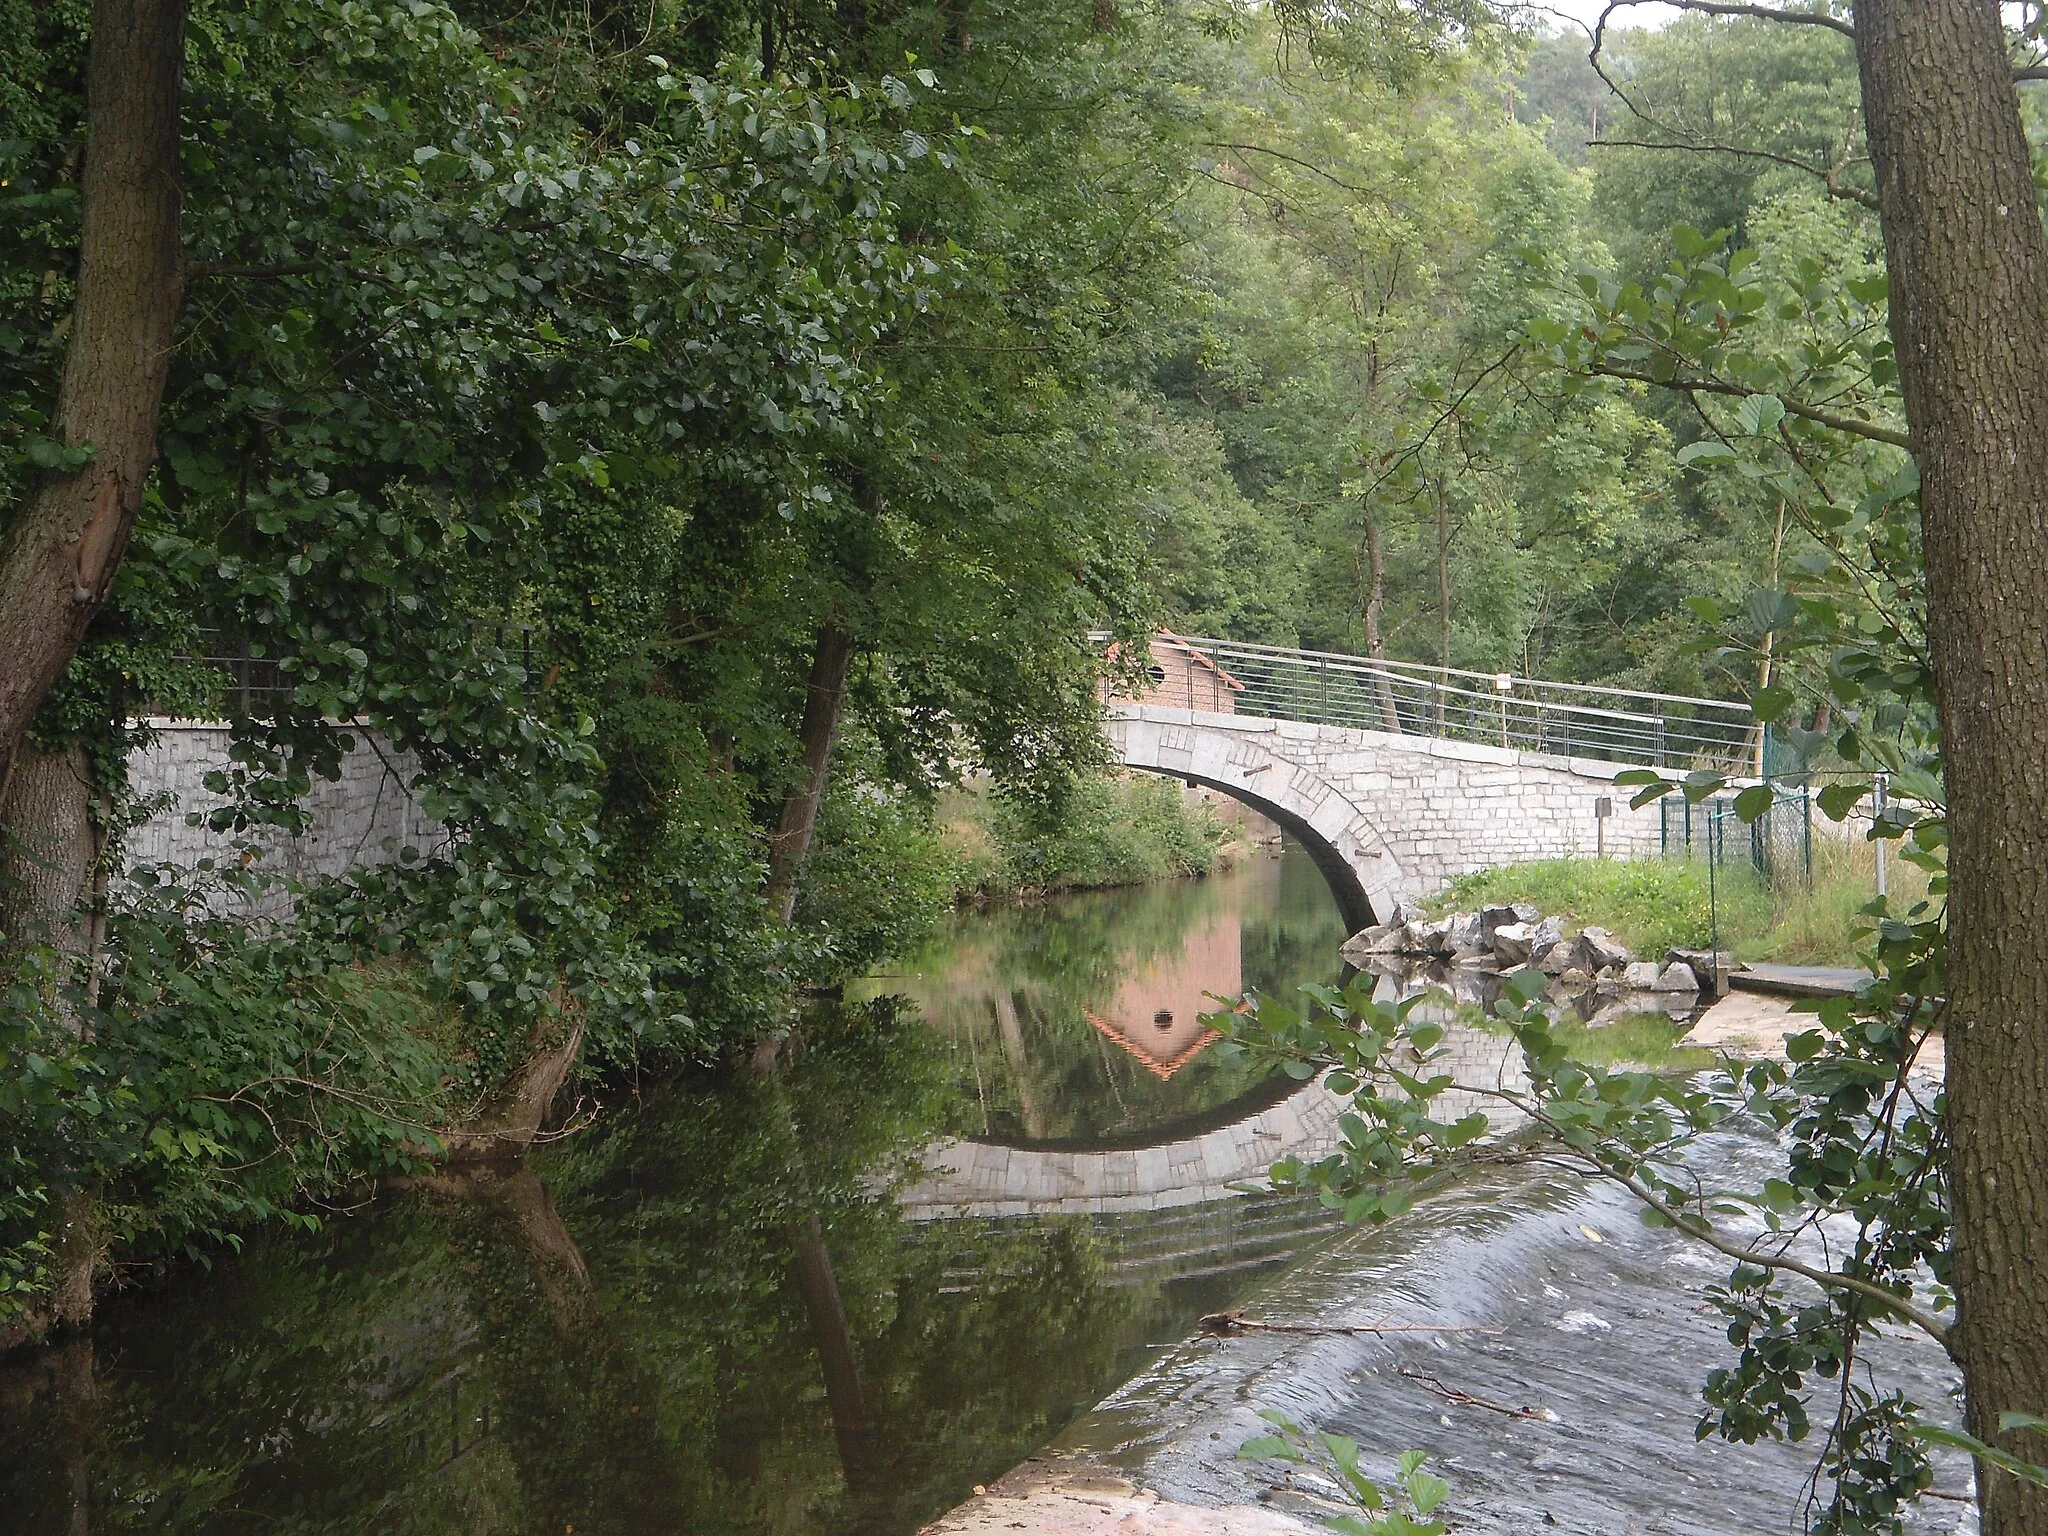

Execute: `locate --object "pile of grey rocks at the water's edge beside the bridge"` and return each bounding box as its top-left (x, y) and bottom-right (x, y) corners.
top-left (1343, 901), bottom-right (1708, 995)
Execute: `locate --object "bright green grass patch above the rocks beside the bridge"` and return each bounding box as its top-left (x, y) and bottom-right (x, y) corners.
top-left (1432, 827), bottom-right (1927, 965)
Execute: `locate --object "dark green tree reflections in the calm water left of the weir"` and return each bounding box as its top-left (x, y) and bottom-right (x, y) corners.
top-left (0, 1024), bottom-right (1245, 1536)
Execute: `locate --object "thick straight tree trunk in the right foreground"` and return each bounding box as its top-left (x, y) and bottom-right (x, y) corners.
top-left (1855, 0), bottom-right (2048, 1536)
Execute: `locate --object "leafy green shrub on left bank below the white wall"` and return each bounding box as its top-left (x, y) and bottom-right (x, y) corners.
top-left (0, 889), bottom-right (467, 1333)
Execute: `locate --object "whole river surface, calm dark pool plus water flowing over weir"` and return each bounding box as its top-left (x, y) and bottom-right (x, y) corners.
top-left (0, 844), bottom-right (1972, 1536)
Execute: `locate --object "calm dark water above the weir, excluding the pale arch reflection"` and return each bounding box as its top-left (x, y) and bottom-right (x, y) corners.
top-left (0, 846), bottom-right (1343, 1536)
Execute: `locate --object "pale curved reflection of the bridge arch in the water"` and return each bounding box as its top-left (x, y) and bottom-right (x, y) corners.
top-left (901, 1079), bottom-right (1348, 1221)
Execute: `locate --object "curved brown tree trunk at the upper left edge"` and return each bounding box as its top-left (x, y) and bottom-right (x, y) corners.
top-left (0, 0), bottom-right (184, 786)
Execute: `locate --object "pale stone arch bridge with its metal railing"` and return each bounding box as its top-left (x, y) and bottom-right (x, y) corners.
top-left (1108, 635), bottom-right (1755, 932)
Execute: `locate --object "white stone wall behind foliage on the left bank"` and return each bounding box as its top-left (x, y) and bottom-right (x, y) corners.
top-left (125, 719), bottom-right (446, 901)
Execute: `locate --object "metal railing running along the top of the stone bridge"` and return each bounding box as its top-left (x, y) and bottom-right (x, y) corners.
top-left (1118, 635), bottom-right (1757, 774)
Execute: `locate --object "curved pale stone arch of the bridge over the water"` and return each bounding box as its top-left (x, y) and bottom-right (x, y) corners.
top-left (1108, 705), bottom-right (1409, 934)
